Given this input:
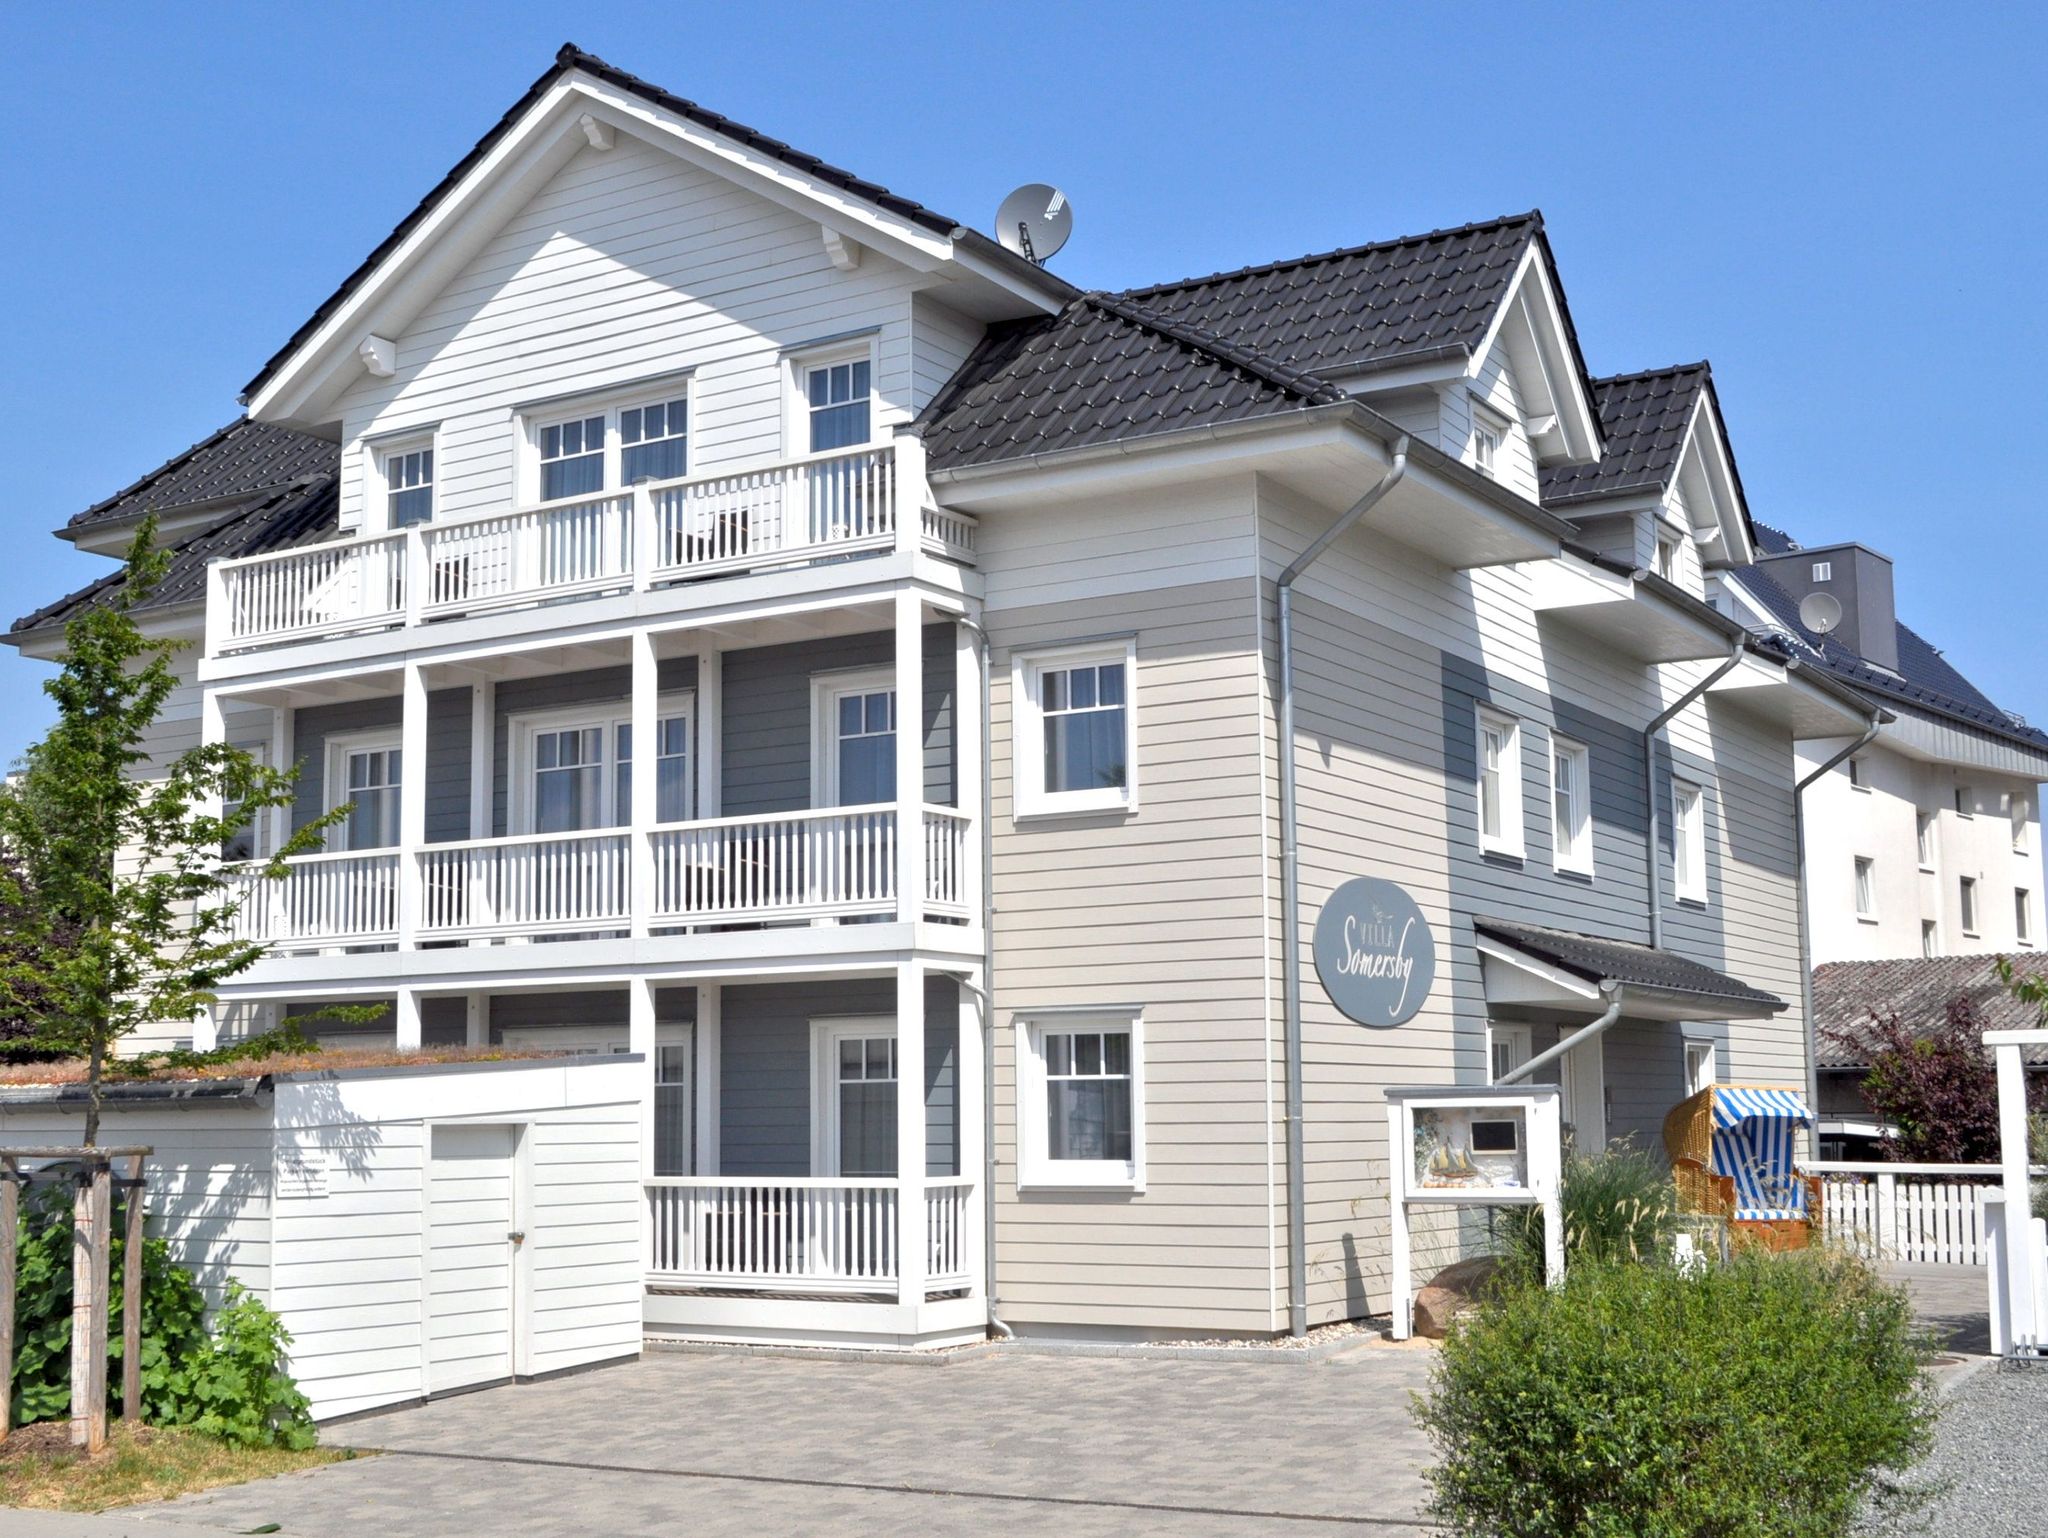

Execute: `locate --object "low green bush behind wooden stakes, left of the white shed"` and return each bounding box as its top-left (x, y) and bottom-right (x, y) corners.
top-left (12, 1180), bottom-right (313, 1448)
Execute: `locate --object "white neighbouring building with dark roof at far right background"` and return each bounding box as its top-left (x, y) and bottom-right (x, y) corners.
top-left (1720, 526), bottom-right (2048, 965)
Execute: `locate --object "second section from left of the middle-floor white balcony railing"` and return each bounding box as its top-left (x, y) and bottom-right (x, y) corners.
top-left (420, 829), bottom-right (633, 940)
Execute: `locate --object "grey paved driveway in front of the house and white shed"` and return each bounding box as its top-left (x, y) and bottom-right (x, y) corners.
top-left (119, 1345), bottom-right (1430, 1538)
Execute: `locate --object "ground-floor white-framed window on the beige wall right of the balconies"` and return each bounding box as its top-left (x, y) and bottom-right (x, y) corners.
top-left (1018, 1012), bottom-right (1145, 1190)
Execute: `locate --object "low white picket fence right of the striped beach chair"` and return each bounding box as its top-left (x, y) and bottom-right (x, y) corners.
top-left (1806, 1159), bottom-right (1999, 1266)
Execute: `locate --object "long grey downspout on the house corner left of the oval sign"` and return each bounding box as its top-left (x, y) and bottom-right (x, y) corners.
top-left (1274, 432), bottom-right (1409, 1335)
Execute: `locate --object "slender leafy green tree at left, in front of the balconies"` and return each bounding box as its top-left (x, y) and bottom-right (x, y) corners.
top-left (0, 518), bottom-right (346, 1145)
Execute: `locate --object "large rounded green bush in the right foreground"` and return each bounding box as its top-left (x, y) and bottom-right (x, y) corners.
top-left (1415, 1251), bottom-right (1933, 1538)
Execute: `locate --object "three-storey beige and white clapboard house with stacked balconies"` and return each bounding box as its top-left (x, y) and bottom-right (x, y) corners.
top-left (12, 49), bottom-right (1876, 1343)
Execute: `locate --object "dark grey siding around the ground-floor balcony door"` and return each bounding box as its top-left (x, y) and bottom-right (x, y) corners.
top-left (719, 977), bottom-right (961, 1176)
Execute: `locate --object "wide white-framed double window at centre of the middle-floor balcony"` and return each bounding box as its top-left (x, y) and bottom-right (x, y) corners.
top-left (510, 690), bottom-right (694, 834)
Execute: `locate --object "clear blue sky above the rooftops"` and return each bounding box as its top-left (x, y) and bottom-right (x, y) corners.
top-left (0, 0), bottom-right (2048, 760)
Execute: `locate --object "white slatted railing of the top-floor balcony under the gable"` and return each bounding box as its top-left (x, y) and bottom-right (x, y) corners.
top-left (207, 444), bottom-right (977, 657)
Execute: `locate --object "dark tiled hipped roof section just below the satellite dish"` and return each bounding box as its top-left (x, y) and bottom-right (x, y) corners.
top-left (920, 293), bottom-right (1343, 469)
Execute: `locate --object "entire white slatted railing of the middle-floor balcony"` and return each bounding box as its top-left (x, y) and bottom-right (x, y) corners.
top-left (229, 805), bottom-right (975, 954)
